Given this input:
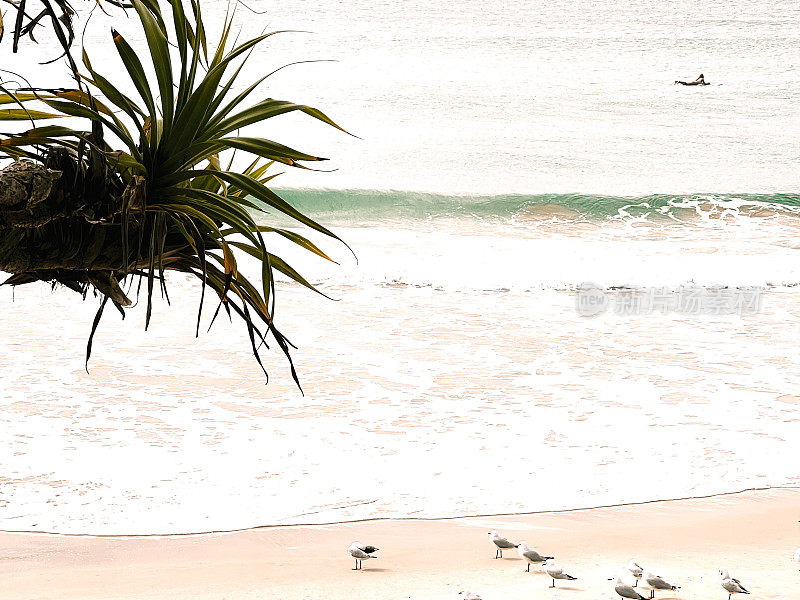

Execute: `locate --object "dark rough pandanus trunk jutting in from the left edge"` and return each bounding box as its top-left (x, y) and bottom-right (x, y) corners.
top-left (0, 153), bottom-right (136, 306)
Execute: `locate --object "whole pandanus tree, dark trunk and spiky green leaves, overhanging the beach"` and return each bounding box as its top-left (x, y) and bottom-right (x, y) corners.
top-left (0, 0), bottom-right (344, 381)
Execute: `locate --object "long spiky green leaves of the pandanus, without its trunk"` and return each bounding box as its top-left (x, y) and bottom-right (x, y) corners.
top-left (0, 0), bottom-right (350, 380)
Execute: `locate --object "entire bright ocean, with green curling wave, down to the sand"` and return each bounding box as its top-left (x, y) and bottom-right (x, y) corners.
top-left (0, 1), bottom-right (800, 534)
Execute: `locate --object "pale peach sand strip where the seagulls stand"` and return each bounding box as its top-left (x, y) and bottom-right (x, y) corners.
top-left (0, 488), bottom-right (800, 600)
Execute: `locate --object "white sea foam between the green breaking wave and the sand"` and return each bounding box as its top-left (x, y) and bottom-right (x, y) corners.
top-left (0, 217), bottom-right (800, 533)
